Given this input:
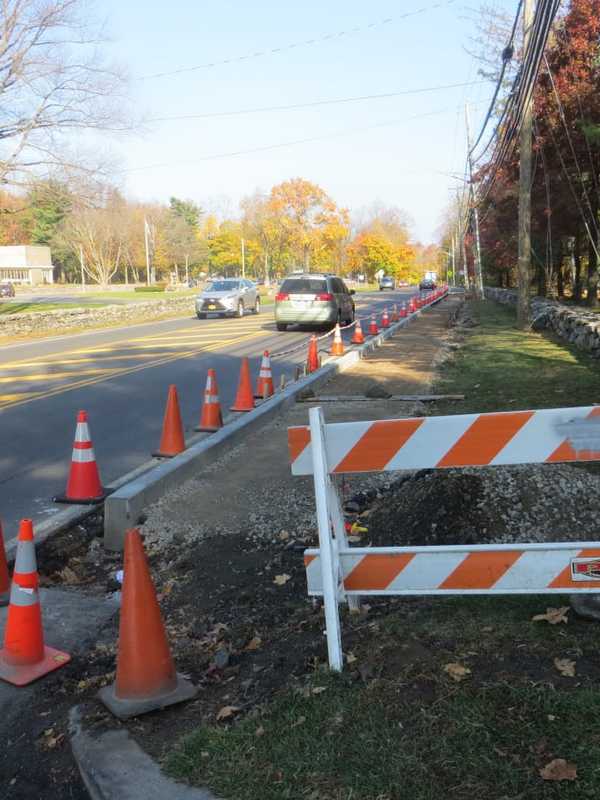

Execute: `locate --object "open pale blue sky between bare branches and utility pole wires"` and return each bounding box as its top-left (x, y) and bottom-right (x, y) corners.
top-left (98, 0), bottom-right (516, 242)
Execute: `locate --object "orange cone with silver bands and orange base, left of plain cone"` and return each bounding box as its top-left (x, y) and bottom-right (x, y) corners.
top-left (0, 519), bottom-right (71, 686)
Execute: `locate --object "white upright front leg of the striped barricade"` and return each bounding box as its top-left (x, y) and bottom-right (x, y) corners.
top-left (309, 408), bottom-right (344, 672)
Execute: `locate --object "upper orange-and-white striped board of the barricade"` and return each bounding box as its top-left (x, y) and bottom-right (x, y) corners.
top-left (288, 406), bottom-right (600, 475)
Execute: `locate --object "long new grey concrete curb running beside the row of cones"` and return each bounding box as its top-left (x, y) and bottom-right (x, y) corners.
top-left (104, 295), bottom-right (446, 550)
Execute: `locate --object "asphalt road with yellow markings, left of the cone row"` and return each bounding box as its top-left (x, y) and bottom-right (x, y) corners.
top-left (0, 289), bottom-right (415, 539)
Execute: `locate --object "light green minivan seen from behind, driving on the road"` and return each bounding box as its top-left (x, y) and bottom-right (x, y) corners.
top-left (275, 272), bottom-right (354, 331)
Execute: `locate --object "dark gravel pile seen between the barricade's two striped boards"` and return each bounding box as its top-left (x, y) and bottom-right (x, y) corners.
top-left (363, 464), bottom-right (600, 546)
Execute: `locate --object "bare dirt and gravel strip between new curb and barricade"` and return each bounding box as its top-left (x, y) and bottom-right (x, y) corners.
top-left (0, 298), bottom-right (468, 800)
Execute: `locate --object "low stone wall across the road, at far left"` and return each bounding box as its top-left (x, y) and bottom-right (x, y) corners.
top-left (0, 297), bottom-right (195, 337)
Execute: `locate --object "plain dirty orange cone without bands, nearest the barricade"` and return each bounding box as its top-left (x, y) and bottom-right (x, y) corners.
top-left (98, 528), bottom-right (197, 719)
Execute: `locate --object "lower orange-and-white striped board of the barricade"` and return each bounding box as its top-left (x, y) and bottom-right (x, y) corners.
top-left (304, 542), bottom-right (600, 595)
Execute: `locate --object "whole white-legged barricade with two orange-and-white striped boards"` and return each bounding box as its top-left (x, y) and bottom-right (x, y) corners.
top-left (288, 406), bottom-right (600, 671)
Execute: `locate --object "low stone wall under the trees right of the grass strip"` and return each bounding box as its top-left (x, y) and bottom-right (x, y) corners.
top-left (485, 287), bottom-right (600, 358)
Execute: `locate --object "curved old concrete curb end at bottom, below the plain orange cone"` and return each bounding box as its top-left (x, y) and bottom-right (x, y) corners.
top-left (69, 706), bottom-right (218, 800)
